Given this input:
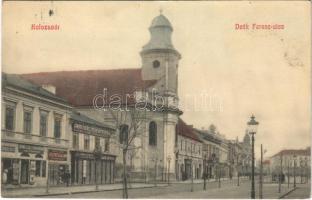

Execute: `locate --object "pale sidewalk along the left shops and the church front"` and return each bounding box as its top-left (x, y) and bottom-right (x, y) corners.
top-left (1, 183), bottom-right (168, 198)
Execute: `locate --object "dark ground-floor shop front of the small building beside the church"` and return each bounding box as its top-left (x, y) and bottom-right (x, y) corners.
top-left (71, 151), bottom-right (116, 185)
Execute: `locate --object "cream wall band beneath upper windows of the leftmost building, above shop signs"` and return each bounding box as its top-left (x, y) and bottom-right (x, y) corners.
top-left (1, 130), bottom-right (69, 146)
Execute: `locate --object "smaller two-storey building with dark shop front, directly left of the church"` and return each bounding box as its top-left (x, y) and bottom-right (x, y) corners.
top-left (70, 111), bottom-right (116, 185)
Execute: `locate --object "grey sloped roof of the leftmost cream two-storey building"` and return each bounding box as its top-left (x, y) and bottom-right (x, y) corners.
top-left (2, 72), bottom-right (68, 104)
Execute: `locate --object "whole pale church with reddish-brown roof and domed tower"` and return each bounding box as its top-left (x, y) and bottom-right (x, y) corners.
top-left (22, 13), bottom-right (186, 180)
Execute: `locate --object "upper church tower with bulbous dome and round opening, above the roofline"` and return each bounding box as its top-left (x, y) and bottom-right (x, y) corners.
top-left (141, 13), bottom-right (181, 97)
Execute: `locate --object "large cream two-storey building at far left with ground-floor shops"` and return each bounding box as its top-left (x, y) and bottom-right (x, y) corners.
top-left (1, 73), bottom-right (71, 185)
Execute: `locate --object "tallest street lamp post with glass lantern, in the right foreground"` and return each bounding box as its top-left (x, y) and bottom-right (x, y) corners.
top-left (247, 115), bottom-right (259, 199)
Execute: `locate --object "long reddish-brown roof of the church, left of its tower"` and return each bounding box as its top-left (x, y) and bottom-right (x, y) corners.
top-left (22, 69), bottom-right (156, 107)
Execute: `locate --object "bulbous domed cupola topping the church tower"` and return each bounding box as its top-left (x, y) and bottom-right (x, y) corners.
top-left (142, 13), bottom-right (175, 52)
